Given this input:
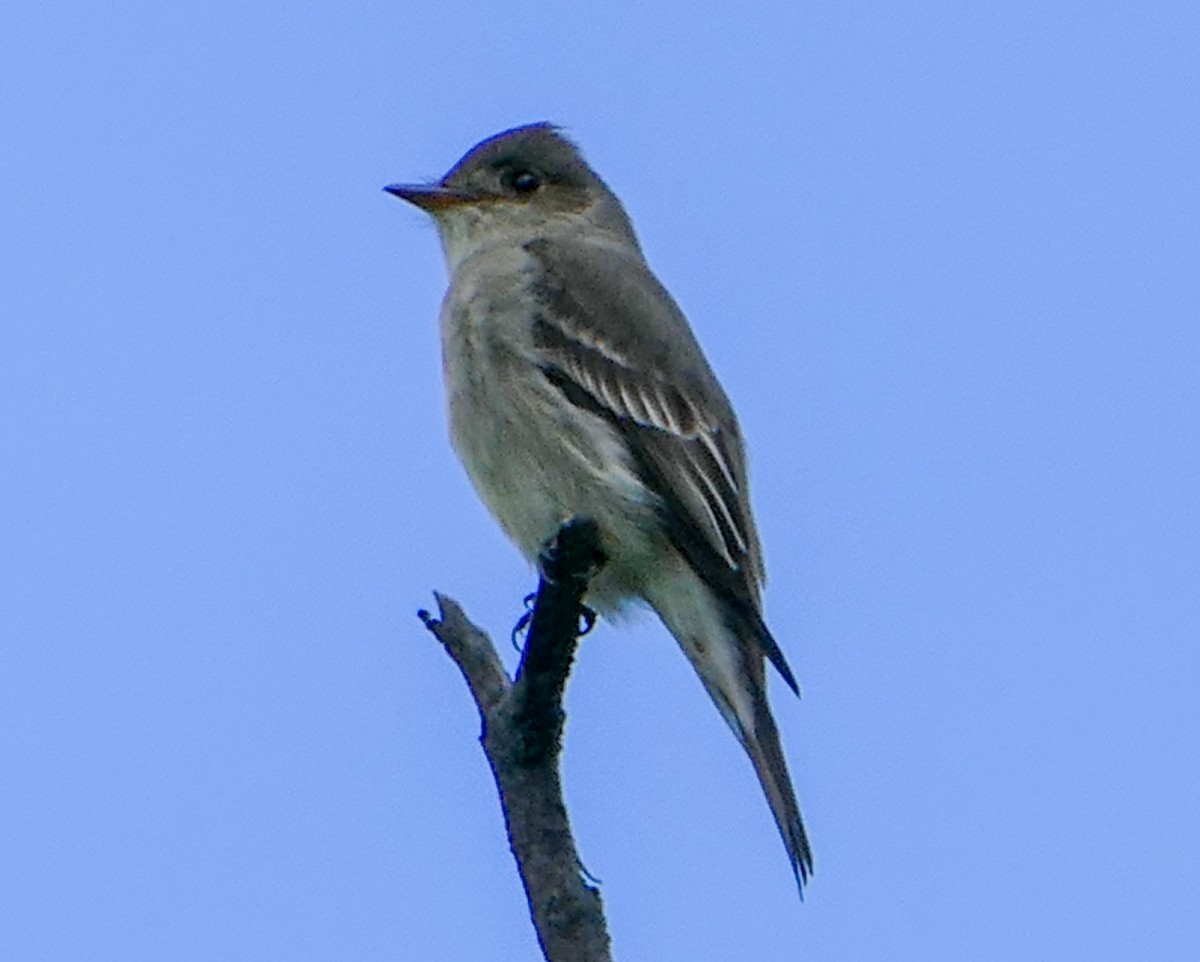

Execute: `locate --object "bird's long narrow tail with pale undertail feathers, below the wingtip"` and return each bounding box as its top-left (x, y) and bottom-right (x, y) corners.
top-left (647, 570), bottom-right (812, 897)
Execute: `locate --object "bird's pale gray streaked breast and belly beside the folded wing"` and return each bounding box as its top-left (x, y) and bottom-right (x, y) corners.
top-left (442, 247), bottom-right (655, 587)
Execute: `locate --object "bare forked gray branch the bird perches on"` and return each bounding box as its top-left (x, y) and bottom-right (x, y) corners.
top-left (419, 518), bottom-right (612, 962)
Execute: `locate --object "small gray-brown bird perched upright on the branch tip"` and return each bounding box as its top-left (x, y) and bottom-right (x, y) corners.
top-left (385, 124), bottom-right (812, 891)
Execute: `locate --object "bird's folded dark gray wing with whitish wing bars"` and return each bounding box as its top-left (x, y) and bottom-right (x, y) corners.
top-left (526, 241), bottom-right (796, 689)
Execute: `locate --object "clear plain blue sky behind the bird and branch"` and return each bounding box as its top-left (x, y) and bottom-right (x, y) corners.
top-left (0, 0), bottom-right (1200, 962)
